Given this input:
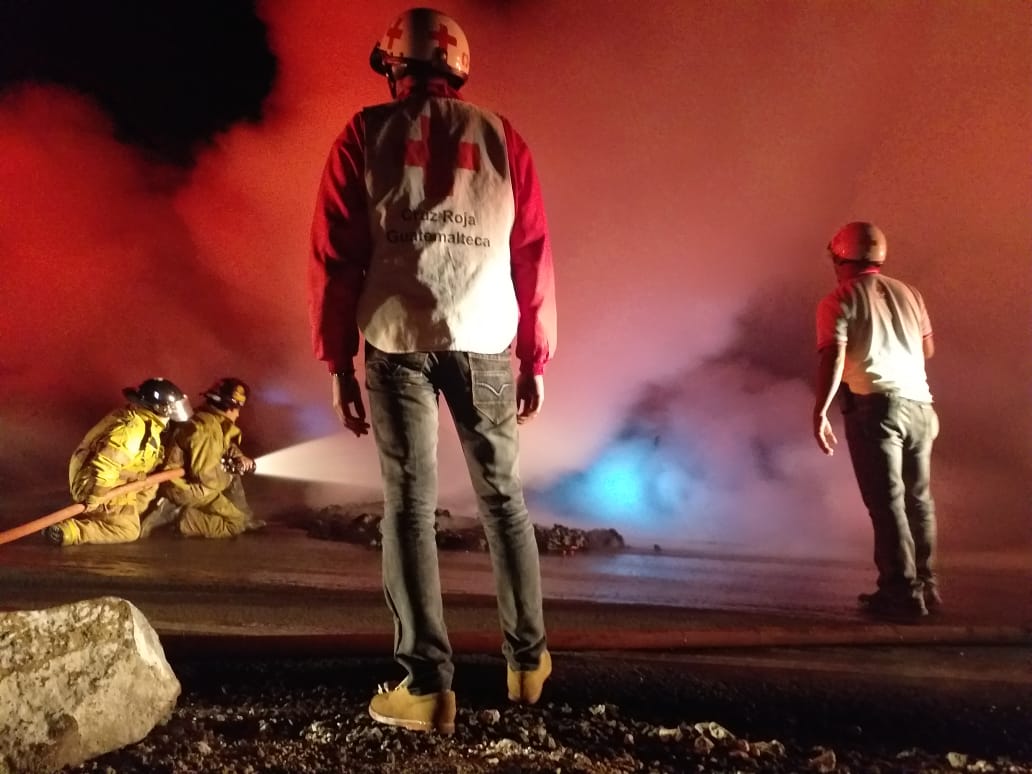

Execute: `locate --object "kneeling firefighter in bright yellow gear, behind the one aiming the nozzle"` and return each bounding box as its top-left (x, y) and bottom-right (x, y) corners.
top-left (43, 379), bottom-right (193, 546)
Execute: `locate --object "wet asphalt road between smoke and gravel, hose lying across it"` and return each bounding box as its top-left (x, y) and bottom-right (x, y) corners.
top-left (0, 526), bottom-right (1032, 653)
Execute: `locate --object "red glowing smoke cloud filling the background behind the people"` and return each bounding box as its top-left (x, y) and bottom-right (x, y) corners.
top-left (0, 0), bottom-right (1032, 550)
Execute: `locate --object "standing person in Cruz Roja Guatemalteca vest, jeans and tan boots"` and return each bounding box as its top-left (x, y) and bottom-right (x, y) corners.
top-left (309, 8), bottom-right (556, 733)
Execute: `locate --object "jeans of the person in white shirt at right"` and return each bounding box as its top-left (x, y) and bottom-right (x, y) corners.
top-left (843, 394), bottom-right (939, 596)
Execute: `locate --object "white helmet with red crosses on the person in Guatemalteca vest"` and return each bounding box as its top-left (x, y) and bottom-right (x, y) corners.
top-left (369, 8), bottom-right (470, 89)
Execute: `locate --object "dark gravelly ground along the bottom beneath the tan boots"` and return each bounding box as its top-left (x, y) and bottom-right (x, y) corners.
top-left (69, 653), bottom-right (1032, 774)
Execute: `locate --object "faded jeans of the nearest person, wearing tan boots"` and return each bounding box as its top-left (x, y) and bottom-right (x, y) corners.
top-left (365, 345), bottom-right (545, 695)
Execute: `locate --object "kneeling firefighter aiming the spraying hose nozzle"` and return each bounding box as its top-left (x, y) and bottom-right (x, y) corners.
top-left (143, 378), bottom-right (265, 538)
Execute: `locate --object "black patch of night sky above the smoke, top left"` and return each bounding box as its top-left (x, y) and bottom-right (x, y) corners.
top-left (0, 0), bottom-right (277, 164)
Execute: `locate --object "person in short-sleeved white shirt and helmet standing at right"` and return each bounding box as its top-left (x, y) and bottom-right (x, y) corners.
top-left (813, 222), bottom-right (942, 619)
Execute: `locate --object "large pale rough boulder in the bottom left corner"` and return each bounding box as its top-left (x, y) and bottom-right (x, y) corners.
top-left (0, 596), bottom-right (180, 774)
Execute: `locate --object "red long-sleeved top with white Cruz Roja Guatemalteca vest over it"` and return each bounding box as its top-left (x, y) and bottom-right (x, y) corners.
top-left (309, 80), bottom-right (556, 375)
